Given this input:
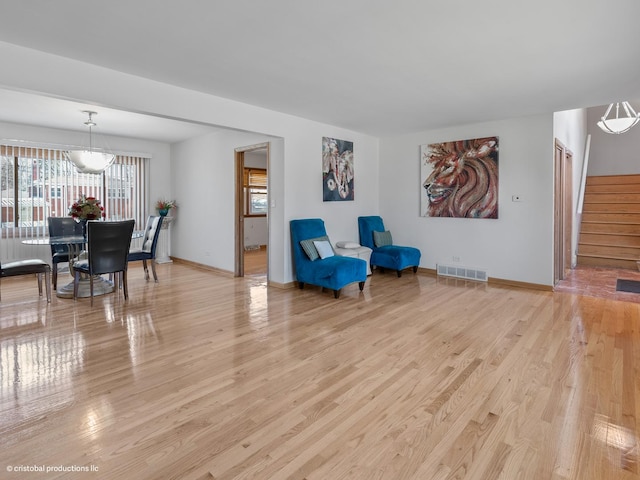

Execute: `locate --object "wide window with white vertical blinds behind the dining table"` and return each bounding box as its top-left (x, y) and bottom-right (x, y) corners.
top-left (0, 145), bottom-right (147, 238)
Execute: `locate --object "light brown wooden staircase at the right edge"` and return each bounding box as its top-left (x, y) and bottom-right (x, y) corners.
top-left (578, 175), bottom-right (640, 270)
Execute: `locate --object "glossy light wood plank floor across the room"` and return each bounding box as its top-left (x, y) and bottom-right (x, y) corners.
top-left (0, 264), bottom-right (640, 480)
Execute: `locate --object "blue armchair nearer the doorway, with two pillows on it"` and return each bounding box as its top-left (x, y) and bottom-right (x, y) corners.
top-left (289, 218), bottom-right (367, 298)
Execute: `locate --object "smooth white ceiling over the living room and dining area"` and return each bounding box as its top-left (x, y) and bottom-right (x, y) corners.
top-left (0, 0), bottom-right (640, 142)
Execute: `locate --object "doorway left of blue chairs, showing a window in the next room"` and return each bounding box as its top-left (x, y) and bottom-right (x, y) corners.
top-left (234, 142), bottom-right (269, 279)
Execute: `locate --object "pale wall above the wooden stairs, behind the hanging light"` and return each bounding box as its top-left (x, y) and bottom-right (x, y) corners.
top-left (587, 101), bottom-right (640, 175)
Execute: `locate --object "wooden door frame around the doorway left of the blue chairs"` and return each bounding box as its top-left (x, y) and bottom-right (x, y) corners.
top-left (233, 142), bottom-right (271, 280)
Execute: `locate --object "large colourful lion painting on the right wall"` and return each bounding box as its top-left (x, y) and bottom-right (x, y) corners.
top-left (420, 137), bottom-right (498, 218)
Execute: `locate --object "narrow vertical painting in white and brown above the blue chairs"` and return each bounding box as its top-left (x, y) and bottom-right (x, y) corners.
top-left (322, 137), bottom-right (354, 202)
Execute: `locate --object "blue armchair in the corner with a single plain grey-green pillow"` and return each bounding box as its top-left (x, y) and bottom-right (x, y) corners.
top-left (358, 216), bottom-right (421, 277)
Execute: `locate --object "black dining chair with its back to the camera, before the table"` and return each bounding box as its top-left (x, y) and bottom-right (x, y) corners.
top-left (73, 220), bottom-right (135, 305)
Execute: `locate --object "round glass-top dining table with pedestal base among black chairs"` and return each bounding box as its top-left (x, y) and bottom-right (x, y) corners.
top-left (22, 230), bottom-right (144, 298)
